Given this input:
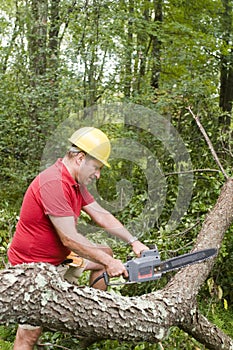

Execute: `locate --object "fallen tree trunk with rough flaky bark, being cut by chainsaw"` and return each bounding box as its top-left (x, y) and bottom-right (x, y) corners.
top-left (0, 179), bottom-right (233, 350)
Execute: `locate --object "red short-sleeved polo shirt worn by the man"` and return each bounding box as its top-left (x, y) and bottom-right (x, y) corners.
top-left (8, 159), bottom-right (94, 265)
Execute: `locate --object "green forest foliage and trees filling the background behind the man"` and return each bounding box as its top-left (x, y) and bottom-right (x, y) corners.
top-left (0, 0), bottom-right (233, 350)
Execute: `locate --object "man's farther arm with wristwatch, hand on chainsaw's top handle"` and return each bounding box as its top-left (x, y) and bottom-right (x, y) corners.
top-left (83, 201), bottom-right (148, 256)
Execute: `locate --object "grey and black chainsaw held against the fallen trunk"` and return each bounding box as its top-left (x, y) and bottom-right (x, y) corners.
top-left (96, 246), bottom-right (217, 286)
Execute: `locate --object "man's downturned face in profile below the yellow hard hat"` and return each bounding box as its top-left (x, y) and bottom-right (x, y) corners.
top-left (76, 156), bottom-right (103, 185)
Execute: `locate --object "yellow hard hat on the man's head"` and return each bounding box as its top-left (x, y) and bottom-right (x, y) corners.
top-left (69, 126), bottom-right (111, 167)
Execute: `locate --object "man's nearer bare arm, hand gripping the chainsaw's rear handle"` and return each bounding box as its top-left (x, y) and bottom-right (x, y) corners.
top-left (49, 215), bottom-right (128, 277)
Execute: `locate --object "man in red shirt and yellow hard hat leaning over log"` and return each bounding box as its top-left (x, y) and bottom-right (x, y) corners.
top-left (8, 127), bottom-right (148, 350)
